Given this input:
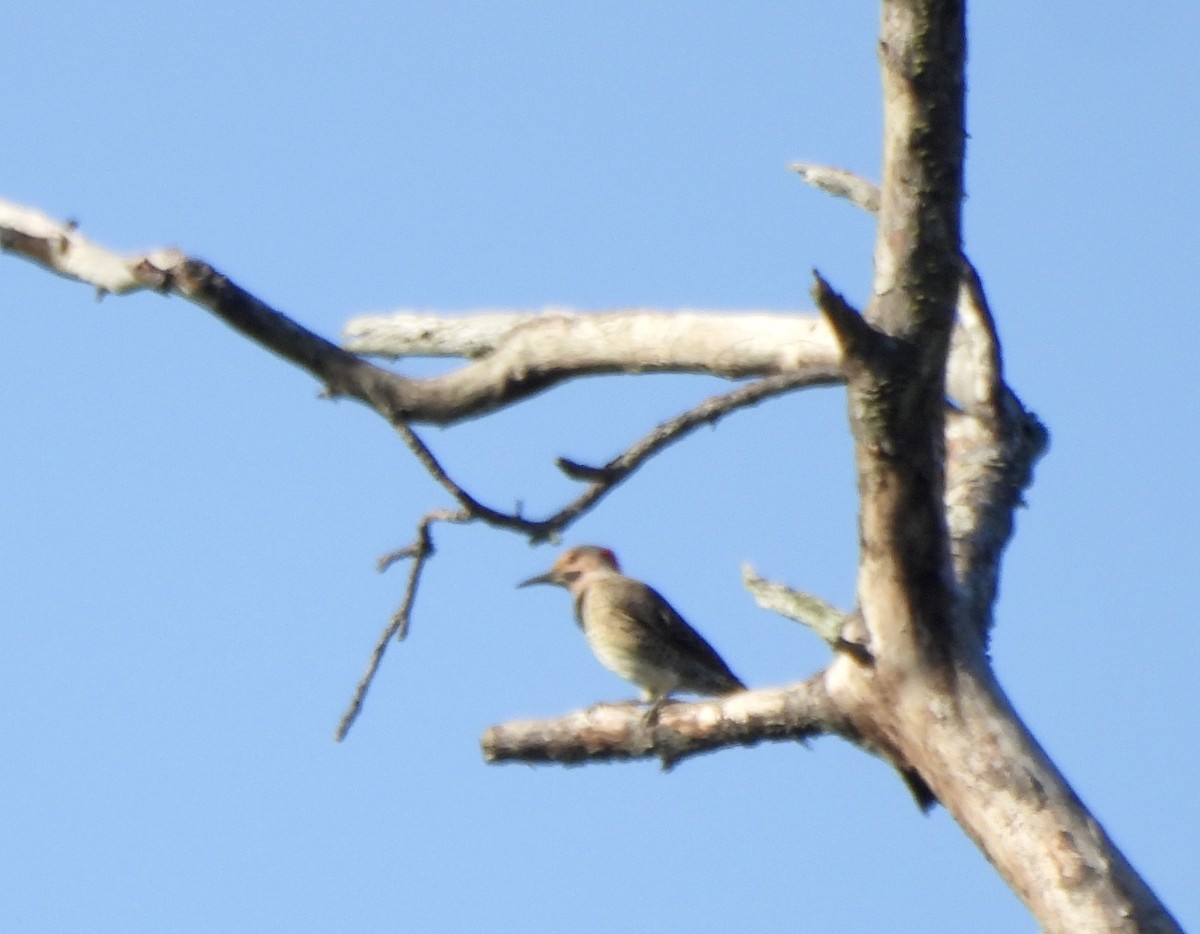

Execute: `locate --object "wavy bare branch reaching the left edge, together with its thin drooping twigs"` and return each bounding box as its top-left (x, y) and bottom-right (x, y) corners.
top-left (0, 194), bottom-right (854, 741)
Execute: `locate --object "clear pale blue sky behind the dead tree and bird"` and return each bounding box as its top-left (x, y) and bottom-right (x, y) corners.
top-left (0, 0), bottom-right (1200, 934)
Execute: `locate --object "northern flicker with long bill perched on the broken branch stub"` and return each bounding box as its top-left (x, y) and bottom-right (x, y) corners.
top-left (518, 545), bottom-right (745, 722)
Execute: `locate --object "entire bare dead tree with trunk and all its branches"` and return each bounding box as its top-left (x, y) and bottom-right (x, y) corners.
top-left (0, 0), bottom-right (1180, 921)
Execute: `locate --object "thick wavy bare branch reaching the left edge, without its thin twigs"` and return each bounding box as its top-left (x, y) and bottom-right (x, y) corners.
top-left (0, 202), bottom-right (840, 425)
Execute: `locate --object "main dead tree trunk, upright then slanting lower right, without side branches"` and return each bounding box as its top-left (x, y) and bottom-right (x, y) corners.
top-left (822, 0), bottom-right (1177, 933)
